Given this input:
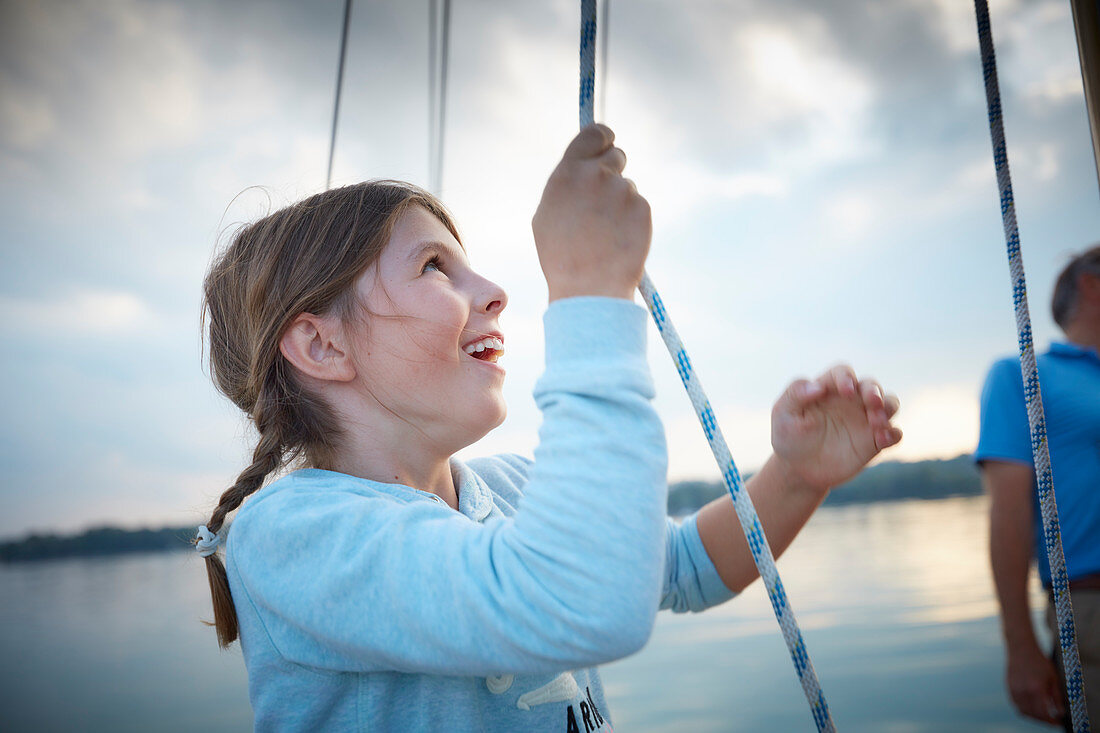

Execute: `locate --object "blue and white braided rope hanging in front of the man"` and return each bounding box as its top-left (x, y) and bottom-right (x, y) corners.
top-left (974, 0), bottom-right (1089, 733)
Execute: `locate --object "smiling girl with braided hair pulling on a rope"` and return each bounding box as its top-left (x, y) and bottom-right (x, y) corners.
top-left (197, 125), bottom-right (901, 732)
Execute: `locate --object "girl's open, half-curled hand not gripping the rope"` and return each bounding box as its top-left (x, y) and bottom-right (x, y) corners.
top-left (771, 364), bottom-right (901, 492)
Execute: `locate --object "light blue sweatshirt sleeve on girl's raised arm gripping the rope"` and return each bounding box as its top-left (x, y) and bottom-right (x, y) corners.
top-left (227, 297), bottom-right (668, 676)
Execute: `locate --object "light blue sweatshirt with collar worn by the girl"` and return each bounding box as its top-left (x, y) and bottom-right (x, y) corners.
top-left (227, 297), bottom-right (733, 733)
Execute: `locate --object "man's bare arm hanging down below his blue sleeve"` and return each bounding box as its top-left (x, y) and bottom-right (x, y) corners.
top-left (981, 460), bottom-right (1065, 723)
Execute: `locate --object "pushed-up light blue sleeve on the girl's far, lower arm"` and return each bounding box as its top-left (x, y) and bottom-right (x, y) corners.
top-left (661, 514), bottom-right (737, 613)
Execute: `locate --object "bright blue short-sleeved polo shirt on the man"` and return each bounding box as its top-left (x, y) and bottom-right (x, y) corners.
top-left (974, 343), bottom-right (1100, 588)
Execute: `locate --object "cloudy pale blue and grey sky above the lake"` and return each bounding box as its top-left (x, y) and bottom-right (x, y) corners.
top-left (0, 0), bottom-right (1100, 537)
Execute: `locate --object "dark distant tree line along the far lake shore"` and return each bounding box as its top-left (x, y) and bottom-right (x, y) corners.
top-left (0, 456), bottom-right (981, 562)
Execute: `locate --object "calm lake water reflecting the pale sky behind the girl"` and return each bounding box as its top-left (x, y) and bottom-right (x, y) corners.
top-left (0, 496), bottom-right (1052, 733)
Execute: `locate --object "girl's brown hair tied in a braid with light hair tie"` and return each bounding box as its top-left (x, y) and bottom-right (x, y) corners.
top-left (202, 180), bottom-right (459, 647)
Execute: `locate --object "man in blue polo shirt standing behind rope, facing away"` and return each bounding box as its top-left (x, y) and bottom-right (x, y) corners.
top-left (975, 245), bottom-right (1100, 730)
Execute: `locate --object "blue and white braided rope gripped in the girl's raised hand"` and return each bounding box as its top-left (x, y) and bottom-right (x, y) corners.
top-left (580, 0), bottom-right (836, 731)
